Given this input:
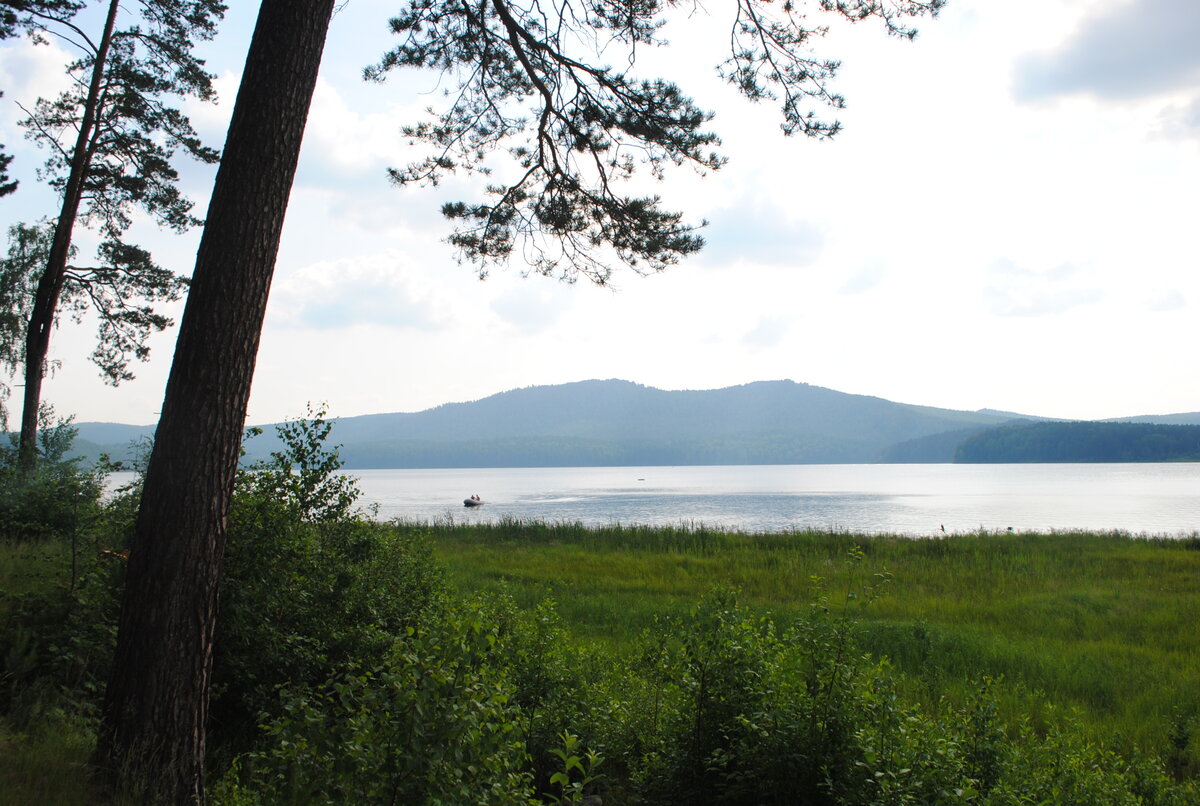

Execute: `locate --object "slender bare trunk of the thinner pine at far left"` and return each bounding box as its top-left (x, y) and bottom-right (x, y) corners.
top-left (17, 0), bottom-right (120, 473)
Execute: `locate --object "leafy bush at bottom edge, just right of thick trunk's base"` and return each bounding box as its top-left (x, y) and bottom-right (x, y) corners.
top-left (211, 603), bottom-right (535, 806)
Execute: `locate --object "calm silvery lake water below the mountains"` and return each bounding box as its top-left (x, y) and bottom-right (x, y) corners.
top-left (352, 463), bottom-right (1200, 535)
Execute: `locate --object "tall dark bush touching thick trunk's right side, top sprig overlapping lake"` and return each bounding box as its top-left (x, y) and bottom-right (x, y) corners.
top-left (210, 409), bottom-right (443, 759)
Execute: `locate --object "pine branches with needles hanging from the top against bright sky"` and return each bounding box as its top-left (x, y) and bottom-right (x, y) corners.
top-left (365, 0), bottom-right (944, 284)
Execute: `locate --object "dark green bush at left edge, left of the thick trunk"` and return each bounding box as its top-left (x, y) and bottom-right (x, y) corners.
top-left (0, 422), bottom-right (136, 730)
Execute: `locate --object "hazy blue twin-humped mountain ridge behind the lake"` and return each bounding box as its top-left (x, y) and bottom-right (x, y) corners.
top-left (65, 380), bottom-right (1200, 469)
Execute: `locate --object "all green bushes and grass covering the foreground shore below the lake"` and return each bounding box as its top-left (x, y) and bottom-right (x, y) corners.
top-left (0, 413), bottom-right (1200, 806)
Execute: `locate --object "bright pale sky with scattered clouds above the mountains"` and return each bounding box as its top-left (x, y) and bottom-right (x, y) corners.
top-left (0, 0), bottom-right (1200, 425)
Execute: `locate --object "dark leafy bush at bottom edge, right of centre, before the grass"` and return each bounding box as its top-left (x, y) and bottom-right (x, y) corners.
top-left (607, 555), bottom-right (886, 804)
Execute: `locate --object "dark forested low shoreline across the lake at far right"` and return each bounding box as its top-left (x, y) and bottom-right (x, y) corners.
top-left (954, 422), bottom-right (1200, 463)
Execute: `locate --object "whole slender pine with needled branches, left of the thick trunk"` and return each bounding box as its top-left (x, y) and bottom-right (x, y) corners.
top-left (11, 0), bottom-right (224, 469)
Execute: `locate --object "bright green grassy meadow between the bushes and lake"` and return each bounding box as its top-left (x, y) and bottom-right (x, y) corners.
top-left (412, 522), bottom-right (1200, 754)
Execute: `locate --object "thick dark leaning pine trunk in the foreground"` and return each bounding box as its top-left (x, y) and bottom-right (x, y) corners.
top-left (96, 0), bottom-right (335, 804)
